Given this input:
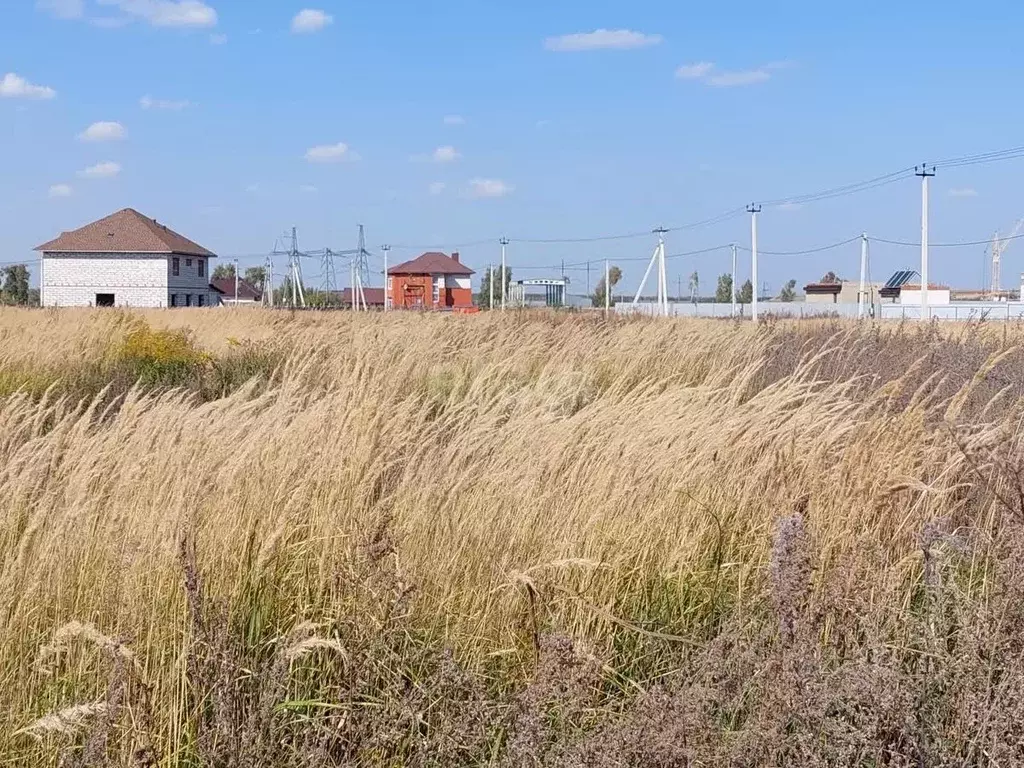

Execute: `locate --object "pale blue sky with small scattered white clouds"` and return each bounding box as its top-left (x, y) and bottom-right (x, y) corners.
top-left (0, 0), bottom-right (1024, 290)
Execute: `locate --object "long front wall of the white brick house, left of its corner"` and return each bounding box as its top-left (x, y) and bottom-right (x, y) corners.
top-left (40, 253), bottom-right (168, 307)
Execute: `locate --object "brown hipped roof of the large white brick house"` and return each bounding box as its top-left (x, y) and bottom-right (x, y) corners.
top-left (36, 208), bottom-right (215, 256)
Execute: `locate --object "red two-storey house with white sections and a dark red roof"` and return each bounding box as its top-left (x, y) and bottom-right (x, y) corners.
top-left (387, 252), bottom-right (473, 309)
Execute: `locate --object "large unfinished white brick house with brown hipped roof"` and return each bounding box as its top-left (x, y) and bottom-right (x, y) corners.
top-left (36, 208), bottom-right (219, 307)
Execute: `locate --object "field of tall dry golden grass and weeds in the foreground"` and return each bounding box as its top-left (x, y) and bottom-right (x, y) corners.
top-left (0, 309), bottom-right (1024, 768)
